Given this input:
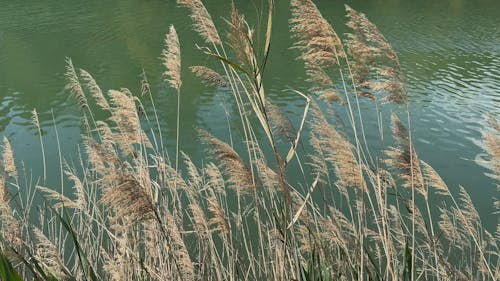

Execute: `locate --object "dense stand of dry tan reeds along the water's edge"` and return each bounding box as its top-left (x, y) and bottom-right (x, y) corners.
top-left (0, 0), bottom-right (500, 281)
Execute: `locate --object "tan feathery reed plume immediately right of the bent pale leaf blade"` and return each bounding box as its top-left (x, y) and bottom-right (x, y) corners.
top-left (311, 102), bottom-right (366, 191)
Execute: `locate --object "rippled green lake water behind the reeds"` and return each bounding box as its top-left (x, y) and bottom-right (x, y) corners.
top-left (0, 0), bottom-right (500, 230)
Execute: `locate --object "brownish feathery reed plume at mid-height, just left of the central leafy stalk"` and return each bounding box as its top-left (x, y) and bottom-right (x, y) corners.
top-left (198, 129), bottom-right (255, 191)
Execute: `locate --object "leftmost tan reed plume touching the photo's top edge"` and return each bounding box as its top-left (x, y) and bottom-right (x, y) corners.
top-left (177, 0), bottom-right (222, 45)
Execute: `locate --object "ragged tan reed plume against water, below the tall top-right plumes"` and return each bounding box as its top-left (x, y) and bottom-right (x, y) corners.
top-left (386, 113), bottom-right (427, 196)
